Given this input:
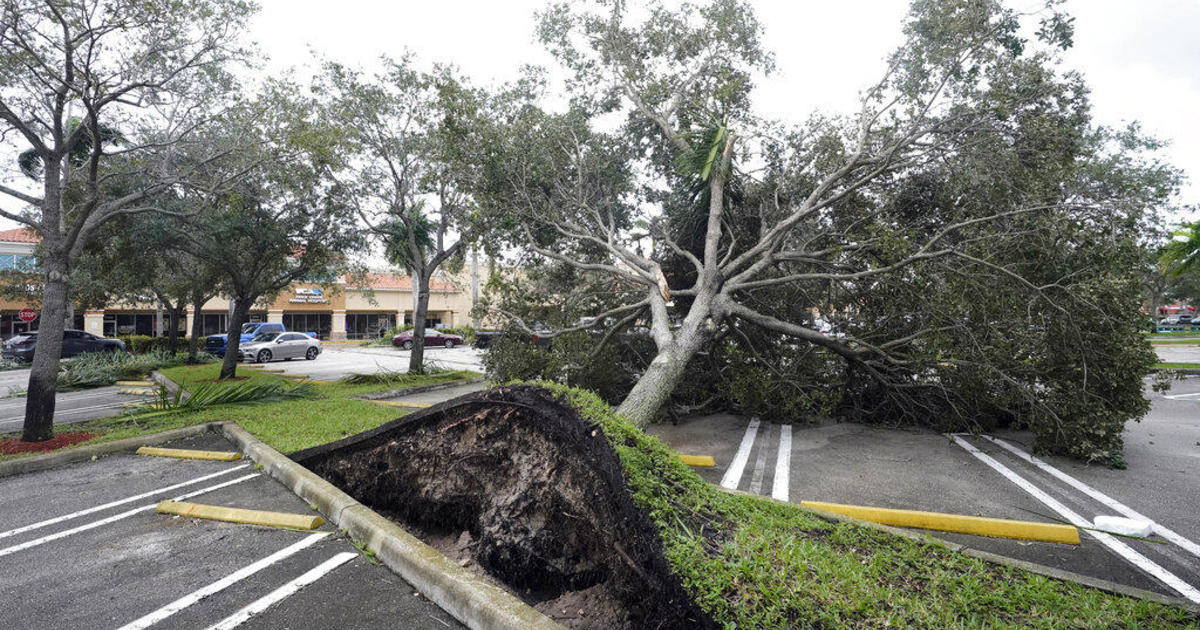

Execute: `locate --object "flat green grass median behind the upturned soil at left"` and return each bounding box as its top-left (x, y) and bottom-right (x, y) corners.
top-left (8, 364), bottom-right (479, 458)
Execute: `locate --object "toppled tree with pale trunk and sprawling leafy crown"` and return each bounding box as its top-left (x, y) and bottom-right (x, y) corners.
top-left (490, 0), bottom-right (1178, 463)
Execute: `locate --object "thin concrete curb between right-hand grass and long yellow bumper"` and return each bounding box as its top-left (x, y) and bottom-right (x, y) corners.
top-left (714, 486), bottom-right (1200, 613)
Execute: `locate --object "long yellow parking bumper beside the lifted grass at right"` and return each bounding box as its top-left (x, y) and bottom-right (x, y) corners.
top-left (800, 500), bottom-right (1079, 545)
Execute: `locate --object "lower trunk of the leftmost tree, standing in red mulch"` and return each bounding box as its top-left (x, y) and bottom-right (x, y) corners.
top-left (20, 258), bottom-right (67, 442)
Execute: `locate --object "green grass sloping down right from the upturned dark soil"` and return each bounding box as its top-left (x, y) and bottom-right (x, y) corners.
top-left (542, 384), bottom-right (1200, 629)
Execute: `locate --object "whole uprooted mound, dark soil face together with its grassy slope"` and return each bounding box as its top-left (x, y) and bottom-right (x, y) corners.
top-left (292, 384), bottom-right (1196, 629)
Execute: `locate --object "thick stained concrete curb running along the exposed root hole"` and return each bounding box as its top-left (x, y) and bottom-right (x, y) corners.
top-left (221, 420), bottom-right (563, 630)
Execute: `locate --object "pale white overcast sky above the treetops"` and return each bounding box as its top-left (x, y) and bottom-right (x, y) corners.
top-left (5, 0), bottom-right (1200, 229)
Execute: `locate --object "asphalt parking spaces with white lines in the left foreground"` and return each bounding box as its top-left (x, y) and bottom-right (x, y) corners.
top-left (0, 434), bottom-right (461, 630)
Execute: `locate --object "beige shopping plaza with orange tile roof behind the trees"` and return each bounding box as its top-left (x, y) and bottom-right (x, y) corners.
top-left (0, 228), bottom-right (473, 340)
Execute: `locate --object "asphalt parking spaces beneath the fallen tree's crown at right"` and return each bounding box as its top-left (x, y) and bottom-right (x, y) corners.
top-left (652, 378), bottom-right (1200, 601)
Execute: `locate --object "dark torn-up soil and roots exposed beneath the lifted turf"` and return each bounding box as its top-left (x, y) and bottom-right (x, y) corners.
top-left (293, 385), bottom-right (714, 629)
